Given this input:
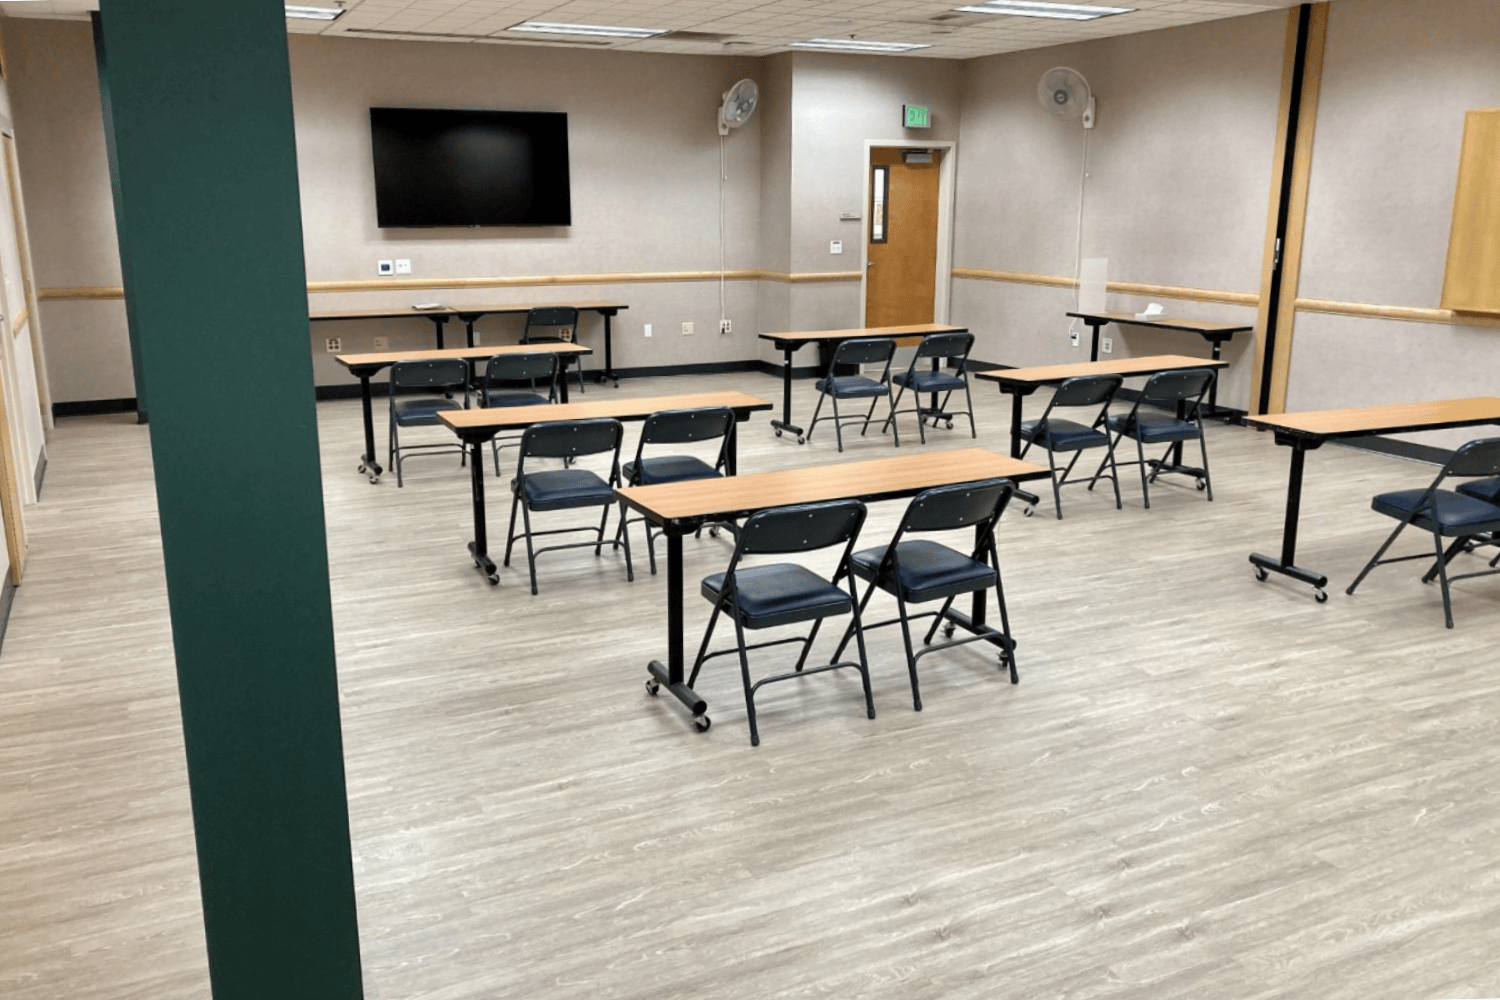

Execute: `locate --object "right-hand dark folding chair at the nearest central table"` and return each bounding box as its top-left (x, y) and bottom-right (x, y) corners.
top-left (834, 480), bottom-right (1020, 712)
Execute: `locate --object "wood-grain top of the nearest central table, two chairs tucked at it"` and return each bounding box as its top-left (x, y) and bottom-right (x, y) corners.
top-left (615, 448), bottom-right (1050, 525)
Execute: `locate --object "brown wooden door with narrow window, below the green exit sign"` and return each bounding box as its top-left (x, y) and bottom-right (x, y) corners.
top-left (864, 147), bottom-right (944, 327)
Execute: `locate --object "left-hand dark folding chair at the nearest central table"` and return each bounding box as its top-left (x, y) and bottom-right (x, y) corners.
top-left (687, 499), bottom-right (875, 747)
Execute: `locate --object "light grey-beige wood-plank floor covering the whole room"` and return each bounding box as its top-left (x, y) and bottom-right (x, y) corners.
top-left (0, 375), bottom-right (1500, 1000)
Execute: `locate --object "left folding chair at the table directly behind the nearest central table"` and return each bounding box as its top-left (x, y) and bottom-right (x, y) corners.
top-left (506, 418), bottom-right (636, 595)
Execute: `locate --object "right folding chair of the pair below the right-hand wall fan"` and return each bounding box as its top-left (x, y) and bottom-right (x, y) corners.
top-left (1091, 369), bottom-right (1214, 510)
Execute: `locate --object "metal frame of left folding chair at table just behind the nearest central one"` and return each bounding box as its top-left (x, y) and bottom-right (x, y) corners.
top-left (504, 417), bottom-right (636, 597)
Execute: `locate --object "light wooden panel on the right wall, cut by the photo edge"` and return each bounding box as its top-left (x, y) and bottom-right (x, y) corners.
top-left (1443, 108), bottom-right (1500, 313)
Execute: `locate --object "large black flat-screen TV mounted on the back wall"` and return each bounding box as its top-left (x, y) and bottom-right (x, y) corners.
top-left (371, 108), bottom-right (573, 228)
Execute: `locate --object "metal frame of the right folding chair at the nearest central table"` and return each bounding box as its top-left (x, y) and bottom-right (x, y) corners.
top-left (834, 480), bottom-right (1020, 712)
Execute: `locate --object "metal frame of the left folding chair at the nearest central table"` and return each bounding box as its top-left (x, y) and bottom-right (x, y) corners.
top-left (687, 499), bottom-right (875, 747)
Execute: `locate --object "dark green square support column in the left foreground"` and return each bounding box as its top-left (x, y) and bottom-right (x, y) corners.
top-left (99, 0), bottom-right (363, 1000)
